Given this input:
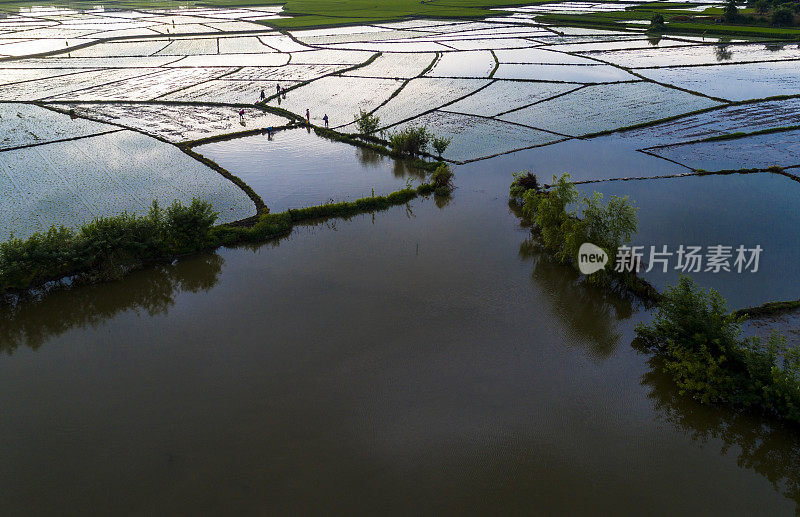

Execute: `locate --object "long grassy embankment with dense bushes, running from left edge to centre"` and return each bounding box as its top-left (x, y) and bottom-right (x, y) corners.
top-left (0, 163), bottom-right (453, 295)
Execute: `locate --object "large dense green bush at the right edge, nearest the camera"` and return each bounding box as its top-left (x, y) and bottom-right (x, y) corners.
top-left (636, 277), bottom-right (800, 424)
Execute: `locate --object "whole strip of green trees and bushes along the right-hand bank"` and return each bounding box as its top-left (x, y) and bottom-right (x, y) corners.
top-left (511, 171), bottom-right (800, 424)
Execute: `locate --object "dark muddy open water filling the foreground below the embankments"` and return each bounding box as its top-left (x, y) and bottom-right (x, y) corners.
top-left (0, 132), bottom-right (800, 515)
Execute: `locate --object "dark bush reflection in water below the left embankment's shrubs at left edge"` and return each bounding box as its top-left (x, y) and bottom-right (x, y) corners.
top-left (0, 253), bottom-right (224, 353)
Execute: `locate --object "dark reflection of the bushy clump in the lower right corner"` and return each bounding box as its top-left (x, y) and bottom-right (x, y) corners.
top-left (641, 356), bottom-right (800, 513)
